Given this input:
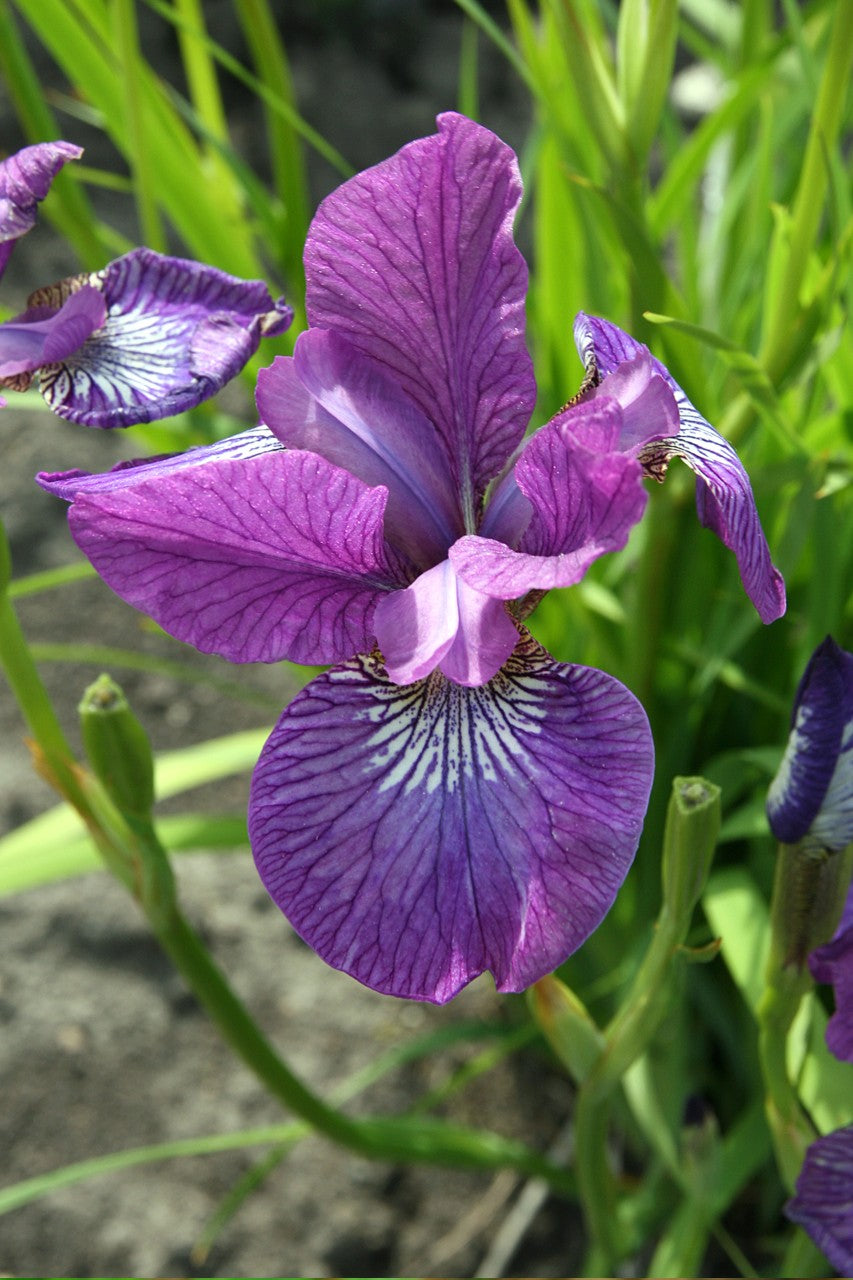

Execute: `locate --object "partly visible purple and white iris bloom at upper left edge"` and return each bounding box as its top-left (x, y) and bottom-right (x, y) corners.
top-left (0, 142), bottom-right (293, 428)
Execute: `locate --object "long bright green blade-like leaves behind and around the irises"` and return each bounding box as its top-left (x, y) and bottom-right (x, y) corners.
top-left (0, 0), bottom-right (853, 1275)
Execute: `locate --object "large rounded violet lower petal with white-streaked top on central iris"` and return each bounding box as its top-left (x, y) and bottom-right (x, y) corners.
top-left (250, 636), bottom-right (652, 1004)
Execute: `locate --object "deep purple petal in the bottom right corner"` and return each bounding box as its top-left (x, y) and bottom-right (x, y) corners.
top-left (785, 1125), bottom-right (853, 1276)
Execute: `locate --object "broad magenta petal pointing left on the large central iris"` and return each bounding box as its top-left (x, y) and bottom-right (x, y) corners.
top-left (42, 439), bottom-right (405, 663)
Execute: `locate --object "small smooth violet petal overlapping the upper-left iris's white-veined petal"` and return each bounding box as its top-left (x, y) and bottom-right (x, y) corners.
top-left (0, 284), bottom-right (106, 390)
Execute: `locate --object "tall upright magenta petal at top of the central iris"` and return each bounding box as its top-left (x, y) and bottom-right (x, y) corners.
top-left (305, 113), bottom-right (535, 531)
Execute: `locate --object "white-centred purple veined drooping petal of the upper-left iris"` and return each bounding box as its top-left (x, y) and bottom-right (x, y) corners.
top-left (31, 248), bottom-right (292, 428)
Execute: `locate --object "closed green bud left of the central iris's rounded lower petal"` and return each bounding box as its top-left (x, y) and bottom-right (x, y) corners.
top-left (78, 676), bottom-right (154, 818)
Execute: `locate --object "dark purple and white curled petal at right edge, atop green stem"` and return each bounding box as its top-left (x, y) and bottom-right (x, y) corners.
top-left (767, 636), bottom-right (853, 851)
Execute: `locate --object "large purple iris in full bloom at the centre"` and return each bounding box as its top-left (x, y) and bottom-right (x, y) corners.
top-left (40, 114), bottom-right (784, 1002)
